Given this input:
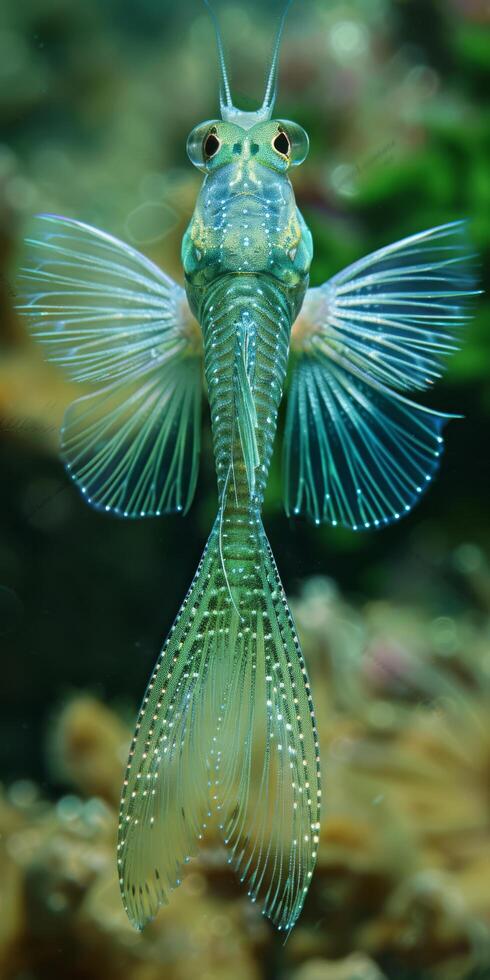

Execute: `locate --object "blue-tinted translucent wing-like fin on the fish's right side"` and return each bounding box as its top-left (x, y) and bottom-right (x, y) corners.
top-left (283, 222), bottom-right (477, 530)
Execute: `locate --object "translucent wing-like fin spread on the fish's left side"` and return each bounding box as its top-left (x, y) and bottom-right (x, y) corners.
top-left (18, 215), bottom-right (202, 517)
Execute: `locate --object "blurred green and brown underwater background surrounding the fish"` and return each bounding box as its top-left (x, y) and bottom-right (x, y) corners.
top-left (0, 0), bottom-right (490, 980)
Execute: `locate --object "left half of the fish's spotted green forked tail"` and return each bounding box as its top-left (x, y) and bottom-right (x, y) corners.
top-left (118, 528), bottom-right (222, 929)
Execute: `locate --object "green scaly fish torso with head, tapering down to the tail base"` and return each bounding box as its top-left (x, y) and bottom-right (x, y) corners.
top-left (182, 123), bottom-right (312, 514)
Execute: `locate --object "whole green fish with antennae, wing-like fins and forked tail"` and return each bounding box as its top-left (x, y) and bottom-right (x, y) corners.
top-left (18, 3), bottom-right (477, 933)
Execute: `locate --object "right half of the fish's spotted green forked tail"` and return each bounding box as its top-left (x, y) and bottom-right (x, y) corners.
top-left (214, 532), bottom-right (321, 931)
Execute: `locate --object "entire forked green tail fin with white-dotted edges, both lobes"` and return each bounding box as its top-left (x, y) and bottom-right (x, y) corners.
top-left (118, 521), bottom-right (320, 930)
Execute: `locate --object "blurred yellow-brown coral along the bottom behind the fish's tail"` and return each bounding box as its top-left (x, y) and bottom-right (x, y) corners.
top-left (0, 579), bottom-right (490, 980)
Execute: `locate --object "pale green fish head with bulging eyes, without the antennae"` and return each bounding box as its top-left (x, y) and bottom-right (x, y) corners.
top-left (182, 119), bottom-right (311, 286)
